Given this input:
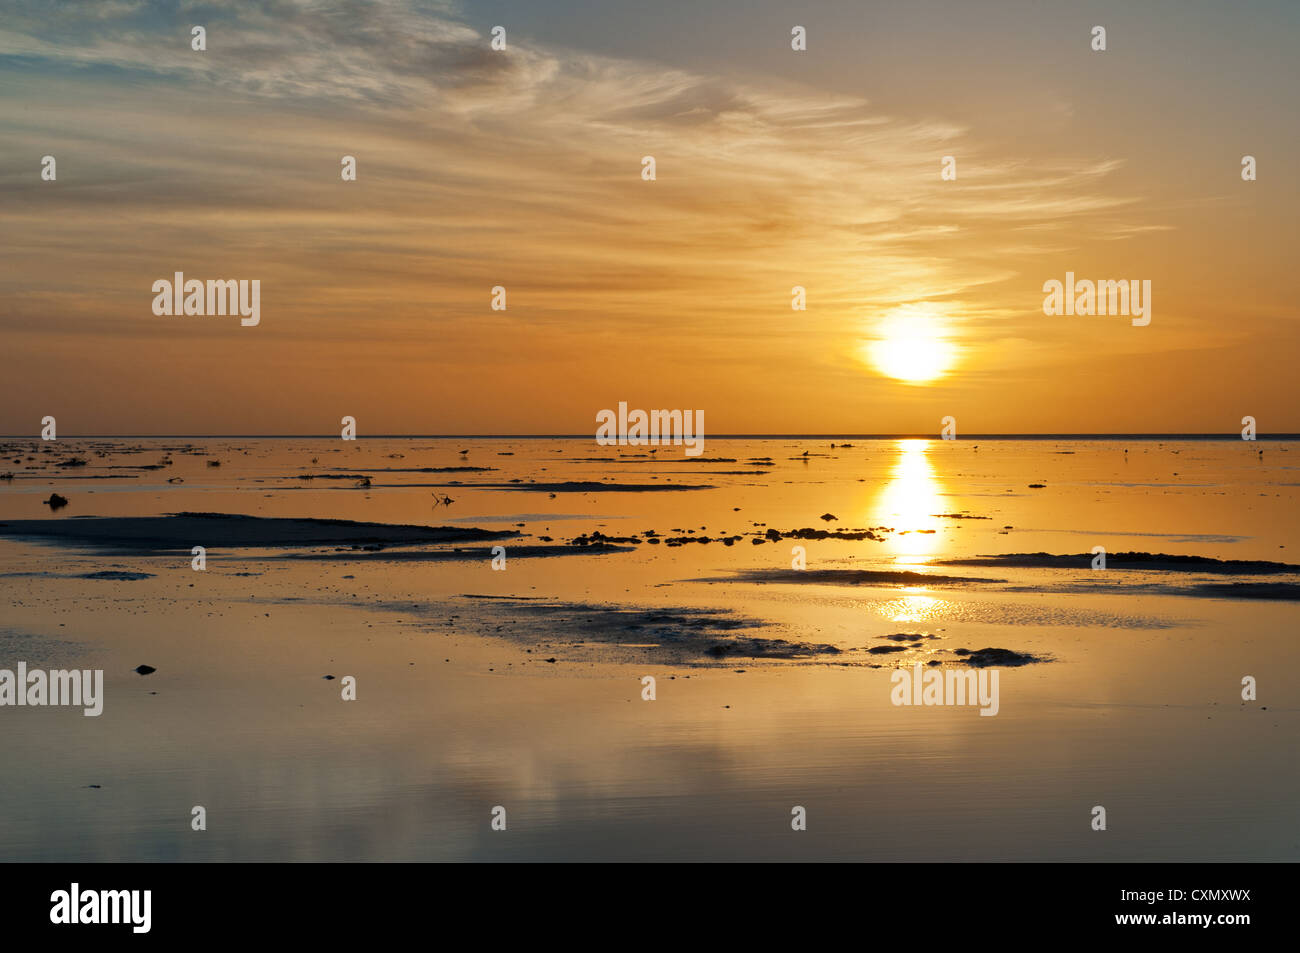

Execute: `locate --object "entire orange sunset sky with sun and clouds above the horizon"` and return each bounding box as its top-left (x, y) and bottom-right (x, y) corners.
top-left (0, 0), bottom-right (1300, 436)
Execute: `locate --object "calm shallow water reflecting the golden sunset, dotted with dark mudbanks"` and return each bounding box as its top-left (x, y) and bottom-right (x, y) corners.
top-left (0, 438), bottom-right (1300, 861)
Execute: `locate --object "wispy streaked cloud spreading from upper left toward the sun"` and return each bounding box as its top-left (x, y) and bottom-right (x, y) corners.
top-left (0, 0), bottom-right (1216, 431)
